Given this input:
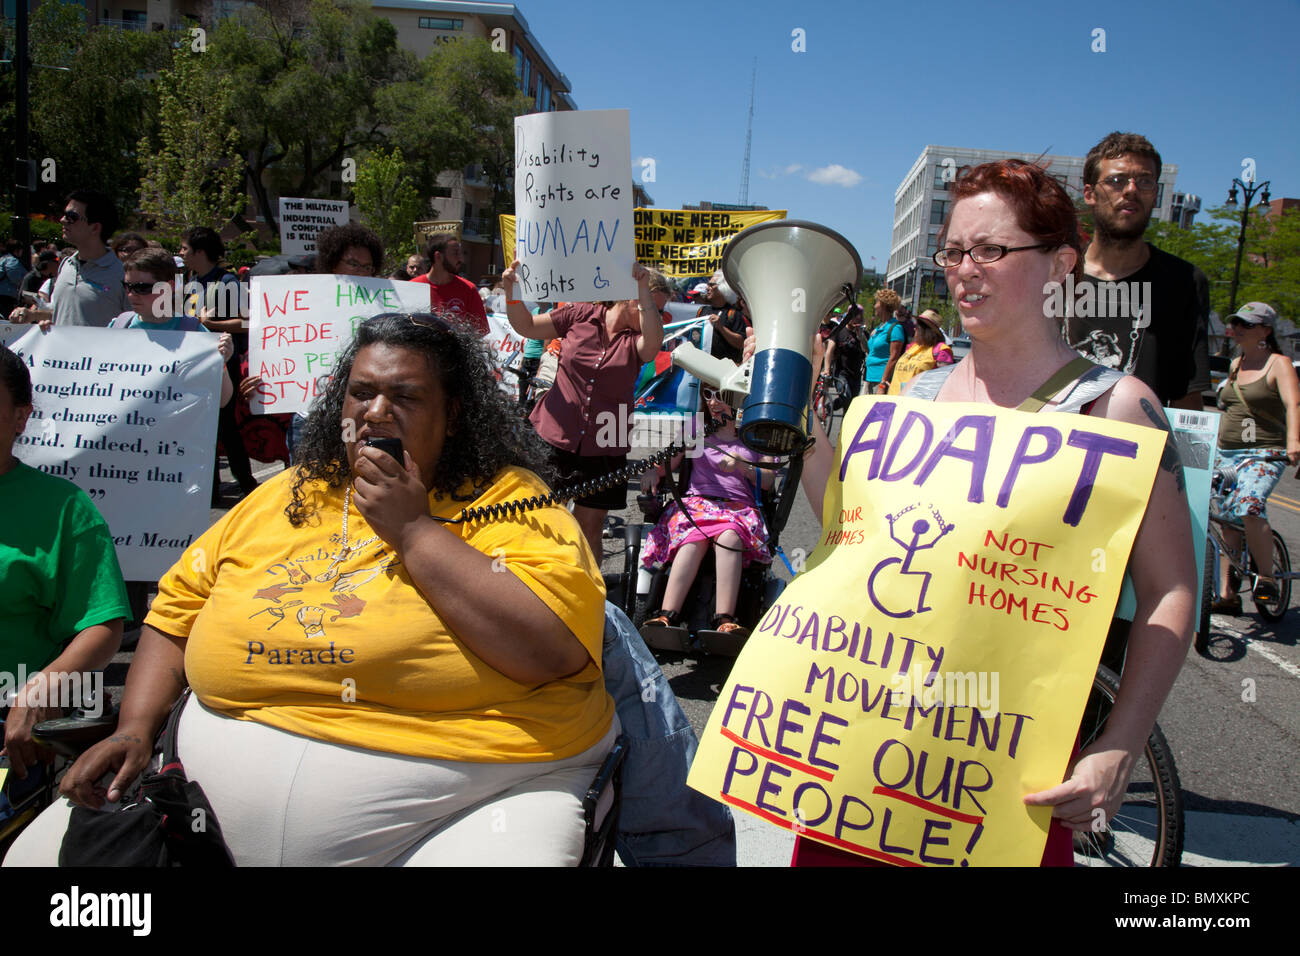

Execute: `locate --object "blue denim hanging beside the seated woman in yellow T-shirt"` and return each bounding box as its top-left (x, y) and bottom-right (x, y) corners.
top-left (603, 602), bottom-right (736, 866)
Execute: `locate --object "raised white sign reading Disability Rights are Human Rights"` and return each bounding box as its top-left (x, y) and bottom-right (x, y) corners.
top-left (502, 109), bottom-right (637, 302)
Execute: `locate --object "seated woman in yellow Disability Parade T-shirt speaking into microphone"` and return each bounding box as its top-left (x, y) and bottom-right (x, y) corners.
top-left (8, 315), bottom-right (618, 865)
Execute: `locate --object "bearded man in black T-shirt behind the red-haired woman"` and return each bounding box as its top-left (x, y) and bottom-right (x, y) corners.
top-left (1065, 133), bottom-right (1210, 410)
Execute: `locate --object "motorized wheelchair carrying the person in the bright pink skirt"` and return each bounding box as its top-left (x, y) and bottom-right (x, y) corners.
top-left (608, 434), bottom-right (803, 657)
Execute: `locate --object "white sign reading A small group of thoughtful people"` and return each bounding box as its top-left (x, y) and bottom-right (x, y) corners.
top-left (0, 325), bottom-right (221, 581)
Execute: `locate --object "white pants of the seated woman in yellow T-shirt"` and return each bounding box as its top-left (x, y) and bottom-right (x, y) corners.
top-left (4, 697), bottom-right (619, 866)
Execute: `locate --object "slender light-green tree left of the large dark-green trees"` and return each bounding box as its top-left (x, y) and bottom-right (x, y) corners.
top-left (139, 43), bottom-right (247, 240)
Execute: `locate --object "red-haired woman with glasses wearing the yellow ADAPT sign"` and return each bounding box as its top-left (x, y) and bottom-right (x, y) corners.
top-left (748, 160), bottom-right (1197, 865)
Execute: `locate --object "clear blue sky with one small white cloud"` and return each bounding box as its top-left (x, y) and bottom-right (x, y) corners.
top-left (517, 0), bottom-right (1300, 268)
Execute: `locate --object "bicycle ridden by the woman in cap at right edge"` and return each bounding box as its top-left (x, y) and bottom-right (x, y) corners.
top-left (1196, 453), bottom-right (1300, 652)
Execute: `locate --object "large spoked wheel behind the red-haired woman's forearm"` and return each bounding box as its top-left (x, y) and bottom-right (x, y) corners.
top-left (1074, 667), bottom-right (1183, 866)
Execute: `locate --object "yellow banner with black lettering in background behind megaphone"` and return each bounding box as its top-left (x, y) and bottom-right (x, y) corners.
top-left (501, 208), bottom-right (785, 276)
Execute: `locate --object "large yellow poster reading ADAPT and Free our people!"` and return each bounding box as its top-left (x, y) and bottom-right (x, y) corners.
top-left (688, 397), bottom-right (1165, 866)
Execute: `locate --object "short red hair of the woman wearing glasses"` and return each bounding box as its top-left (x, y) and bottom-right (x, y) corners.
top-left (939, 160), bottom-right (1083, 280)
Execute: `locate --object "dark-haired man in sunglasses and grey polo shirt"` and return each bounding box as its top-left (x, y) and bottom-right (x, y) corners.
top-left (9, 190), bottom-right (130, 329)
